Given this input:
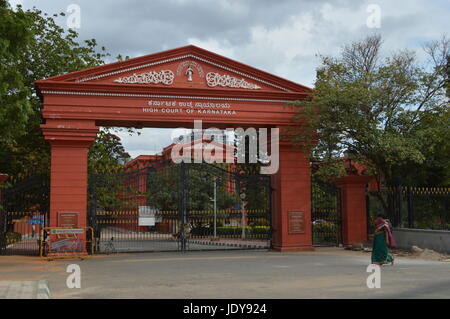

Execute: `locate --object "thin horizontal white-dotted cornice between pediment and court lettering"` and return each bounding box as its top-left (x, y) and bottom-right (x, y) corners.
top-left (42, 91), bottom-right (292, 103)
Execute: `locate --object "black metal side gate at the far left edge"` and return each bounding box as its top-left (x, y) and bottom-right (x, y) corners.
top-left (0, 175), bottom-right (50, 255)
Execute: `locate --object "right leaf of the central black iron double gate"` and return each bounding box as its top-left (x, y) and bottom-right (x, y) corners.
top-left (185, 164), bottom-right (272, 248)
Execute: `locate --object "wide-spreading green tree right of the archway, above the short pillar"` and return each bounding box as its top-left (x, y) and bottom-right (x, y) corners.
top-left (288, 35), bottom-right (450, 189)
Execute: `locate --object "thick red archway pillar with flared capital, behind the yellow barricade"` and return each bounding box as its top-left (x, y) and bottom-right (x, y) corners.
top-left (42, 120), bottom-right (98, 227)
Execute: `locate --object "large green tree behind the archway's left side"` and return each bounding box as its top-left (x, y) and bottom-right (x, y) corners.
top-left (0, 5), bottom-right (132, 176)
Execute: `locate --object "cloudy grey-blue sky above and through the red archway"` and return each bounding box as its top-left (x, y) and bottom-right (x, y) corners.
top-left (11, 0), bottom-right (450, 156)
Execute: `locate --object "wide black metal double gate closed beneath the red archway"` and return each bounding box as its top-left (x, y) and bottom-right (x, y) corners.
top-left (89, 162), bottom-right (271, 253)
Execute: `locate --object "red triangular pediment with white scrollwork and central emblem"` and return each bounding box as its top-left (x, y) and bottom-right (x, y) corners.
top-left (38, 45), bottom-right (310, 93)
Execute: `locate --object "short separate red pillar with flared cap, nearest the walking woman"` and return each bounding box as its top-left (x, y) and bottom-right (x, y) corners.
top-left (335, 175), bottom-right (372, 246)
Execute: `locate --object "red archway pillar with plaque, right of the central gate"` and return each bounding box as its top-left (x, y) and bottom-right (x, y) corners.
top-left (272, 142), bottom-right (313, 251)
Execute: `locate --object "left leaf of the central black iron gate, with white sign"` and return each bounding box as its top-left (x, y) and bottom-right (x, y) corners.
top-left (88, 161), bottom-right (179, 253)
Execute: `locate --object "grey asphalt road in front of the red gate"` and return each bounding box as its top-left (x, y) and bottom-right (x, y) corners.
top-left (0, 248), bottom-right (450, 299)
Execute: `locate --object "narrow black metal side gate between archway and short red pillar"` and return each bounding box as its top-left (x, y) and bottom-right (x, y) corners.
top-left (311, 178), bottom-right (342, 246)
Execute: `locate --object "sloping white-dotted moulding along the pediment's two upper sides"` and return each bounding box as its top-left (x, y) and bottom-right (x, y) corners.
top-left (76, 54), bottom-right (290, 92)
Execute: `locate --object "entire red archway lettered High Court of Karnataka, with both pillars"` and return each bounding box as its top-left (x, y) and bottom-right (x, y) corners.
top-left (36, 45), bottom-right (313, 251)
